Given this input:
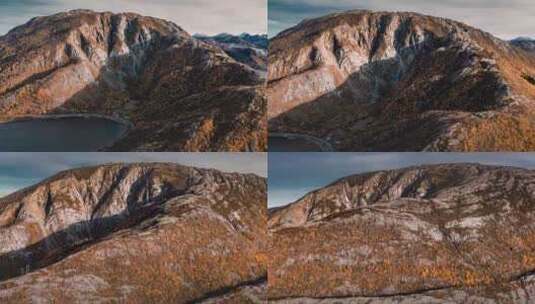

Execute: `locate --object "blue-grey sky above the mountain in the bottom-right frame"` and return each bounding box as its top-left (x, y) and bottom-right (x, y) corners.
top-left (268, 153), bottom-right (535, 208)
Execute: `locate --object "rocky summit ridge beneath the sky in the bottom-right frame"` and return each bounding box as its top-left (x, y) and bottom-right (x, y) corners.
top-left (270, 163), bottom-right (535, 228)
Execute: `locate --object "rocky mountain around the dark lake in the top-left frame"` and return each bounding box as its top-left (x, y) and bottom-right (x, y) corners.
top-left (0, 10), bottom-right (267, 151)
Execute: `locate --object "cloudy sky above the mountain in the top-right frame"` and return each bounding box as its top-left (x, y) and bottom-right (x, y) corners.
top-left (268, 0), bottom-right (535, 39)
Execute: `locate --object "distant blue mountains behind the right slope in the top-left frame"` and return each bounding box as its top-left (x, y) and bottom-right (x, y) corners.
top-left (194, 33), bottom-right (268, 71)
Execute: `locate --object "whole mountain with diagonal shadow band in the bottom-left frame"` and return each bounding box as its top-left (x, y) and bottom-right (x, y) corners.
top-left (0, 163), bottom-right (267, 304)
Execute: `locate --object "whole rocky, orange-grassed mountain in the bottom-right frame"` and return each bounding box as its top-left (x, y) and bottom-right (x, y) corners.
top-left (268, 164), bottom-right (535, 303)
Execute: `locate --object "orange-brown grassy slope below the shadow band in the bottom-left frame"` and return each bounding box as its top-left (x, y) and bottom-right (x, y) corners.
top-left (1, 211), bottom-right (267, 304)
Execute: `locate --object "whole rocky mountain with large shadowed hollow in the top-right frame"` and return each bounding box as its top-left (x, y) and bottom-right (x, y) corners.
top-left (267, 10), bottom-right (535, 151)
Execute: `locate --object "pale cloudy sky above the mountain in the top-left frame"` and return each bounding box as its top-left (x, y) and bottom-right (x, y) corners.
top-left (0, 0), bottom-right (267, 35)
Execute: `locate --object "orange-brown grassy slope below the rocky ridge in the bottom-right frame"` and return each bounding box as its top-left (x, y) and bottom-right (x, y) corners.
top-left (268, 210), bottom-right (535, 299)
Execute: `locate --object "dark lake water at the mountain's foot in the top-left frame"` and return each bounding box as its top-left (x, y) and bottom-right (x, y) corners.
top-left (0, 117), bottom-right (128, 152)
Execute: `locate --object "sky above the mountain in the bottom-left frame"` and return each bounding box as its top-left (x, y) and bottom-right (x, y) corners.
top-left (0, 152), bottom-right (267, 197)
